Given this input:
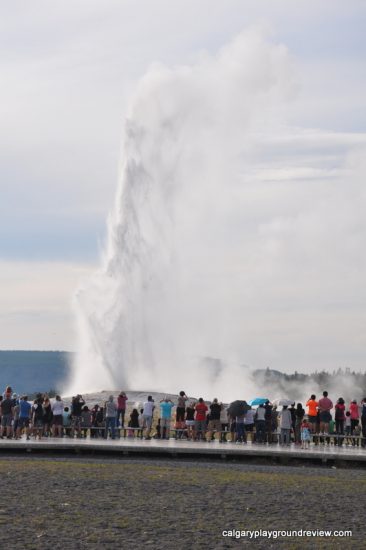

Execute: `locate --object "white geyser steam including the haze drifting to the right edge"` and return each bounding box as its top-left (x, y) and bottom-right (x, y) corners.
top-left (69, 30), bottom-right (366, 400)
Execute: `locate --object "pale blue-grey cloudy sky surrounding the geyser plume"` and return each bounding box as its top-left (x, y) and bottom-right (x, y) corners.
top-left (0, 0), bottom-right (366, 366)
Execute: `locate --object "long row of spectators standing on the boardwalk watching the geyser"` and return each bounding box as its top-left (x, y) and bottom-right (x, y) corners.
top-left (0, 386), bottom-right (366, 448)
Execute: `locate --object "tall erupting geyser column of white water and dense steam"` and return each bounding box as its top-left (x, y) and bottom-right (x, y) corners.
top-left (66, 31), bottom-right (289, 398)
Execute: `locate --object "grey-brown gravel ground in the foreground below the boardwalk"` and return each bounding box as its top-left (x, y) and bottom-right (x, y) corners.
top-left (0, 456), bottom-right (366, 550)
